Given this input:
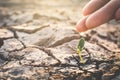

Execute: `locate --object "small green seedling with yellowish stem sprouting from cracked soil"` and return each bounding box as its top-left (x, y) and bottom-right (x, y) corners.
top-left (77, 38), bottom-right (85, 63)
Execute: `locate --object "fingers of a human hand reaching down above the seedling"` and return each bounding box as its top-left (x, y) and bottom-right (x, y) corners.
top-left (76, 0), bottom-right (120, 32)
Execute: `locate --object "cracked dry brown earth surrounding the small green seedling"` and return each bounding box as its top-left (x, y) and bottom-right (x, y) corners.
top-left (0, 0), bottom-right (120, 80)
